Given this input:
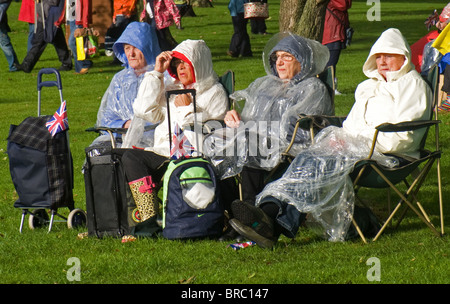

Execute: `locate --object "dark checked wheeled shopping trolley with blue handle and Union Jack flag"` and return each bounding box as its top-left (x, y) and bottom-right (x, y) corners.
top-left (7, 68), bottom-right (86, 232)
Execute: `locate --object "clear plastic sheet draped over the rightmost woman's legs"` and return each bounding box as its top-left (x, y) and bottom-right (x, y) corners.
top-left (256, 127), bottom-right (398, 241)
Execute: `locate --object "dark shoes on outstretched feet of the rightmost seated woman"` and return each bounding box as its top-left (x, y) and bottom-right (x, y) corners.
top-left (229, 201), bottom-right (279, 248)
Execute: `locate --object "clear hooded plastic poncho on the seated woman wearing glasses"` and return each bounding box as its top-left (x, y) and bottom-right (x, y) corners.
top-left (203, 32), bottom-right (334, 179)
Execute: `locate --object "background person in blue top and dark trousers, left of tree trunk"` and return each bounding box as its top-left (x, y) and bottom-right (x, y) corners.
top-left (227, 0), bottom-right (253, 57)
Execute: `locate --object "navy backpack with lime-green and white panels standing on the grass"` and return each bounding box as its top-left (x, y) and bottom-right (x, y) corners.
top-left (163, 157), bottom-right (224, 239)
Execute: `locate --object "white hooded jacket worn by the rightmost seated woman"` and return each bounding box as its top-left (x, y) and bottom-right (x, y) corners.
top-left (343, 29), bottom-right (432, 157)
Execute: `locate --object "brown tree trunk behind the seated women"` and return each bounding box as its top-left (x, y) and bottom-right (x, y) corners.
top-left (279, 0), bottom-right (329, 41)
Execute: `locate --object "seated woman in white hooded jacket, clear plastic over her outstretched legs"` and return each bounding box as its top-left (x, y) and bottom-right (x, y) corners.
top-left (230, 29), bottom-right (432, 248)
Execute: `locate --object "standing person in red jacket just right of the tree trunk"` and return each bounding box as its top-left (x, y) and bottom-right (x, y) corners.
top-left (322, 0), bottom-right (352, 94)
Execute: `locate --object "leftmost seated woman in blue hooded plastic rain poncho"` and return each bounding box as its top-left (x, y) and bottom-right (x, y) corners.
top-left (93, 22), bottom-right (169, 146)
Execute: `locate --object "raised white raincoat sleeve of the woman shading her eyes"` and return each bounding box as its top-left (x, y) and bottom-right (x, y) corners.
top-left (133, 71), bottom-right (165, 123)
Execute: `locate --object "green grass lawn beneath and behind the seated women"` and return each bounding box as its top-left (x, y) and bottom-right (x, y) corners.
top-left (0, 0), bottom-right (450, 284)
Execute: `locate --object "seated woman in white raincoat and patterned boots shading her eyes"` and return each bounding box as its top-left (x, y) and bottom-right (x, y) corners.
top-left (122, 40), bottom-right (228, 232)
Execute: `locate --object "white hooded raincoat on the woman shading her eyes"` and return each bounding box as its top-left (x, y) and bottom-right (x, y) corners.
top-left (129, 40), bottom-right (228, 156)
